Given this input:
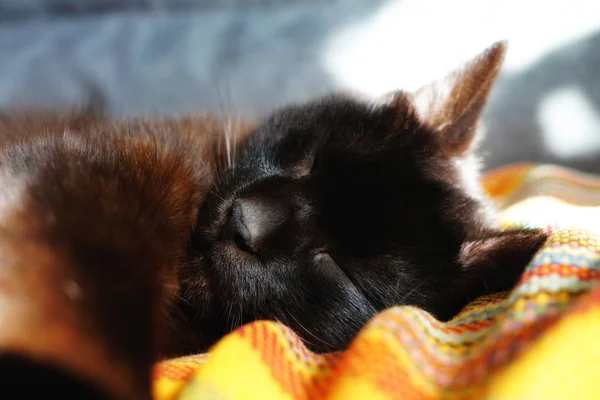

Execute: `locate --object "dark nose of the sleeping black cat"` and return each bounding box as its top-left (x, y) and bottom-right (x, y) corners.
top-left (230, 198), bottom-right (287, 253)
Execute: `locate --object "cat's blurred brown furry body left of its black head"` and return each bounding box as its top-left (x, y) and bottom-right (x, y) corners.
top-left (0, 114), bottom-right (253, 399)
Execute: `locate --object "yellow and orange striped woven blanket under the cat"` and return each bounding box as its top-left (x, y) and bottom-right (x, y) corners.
top-left (154, 164), bottom-right (600, 400)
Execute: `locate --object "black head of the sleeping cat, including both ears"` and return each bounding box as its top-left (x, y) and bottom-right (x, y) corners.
top-left (182, 43), bottom-right (543, 350)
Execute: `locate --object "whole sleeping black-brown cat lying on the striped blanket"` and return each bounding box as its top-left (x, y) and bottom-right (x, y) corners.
top-left (0, 44), bottom-right (546, 398)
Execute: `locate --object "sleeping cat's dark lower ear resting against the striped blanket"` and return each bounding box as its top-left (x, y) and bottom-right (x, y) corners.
top-left (451, 229), bottom-right (549, 314)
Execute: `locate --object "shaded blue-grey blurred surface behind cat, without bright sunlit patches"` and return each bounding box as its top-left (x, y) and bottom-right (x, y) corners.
top-left (0, 0), bottom-right (600, 172)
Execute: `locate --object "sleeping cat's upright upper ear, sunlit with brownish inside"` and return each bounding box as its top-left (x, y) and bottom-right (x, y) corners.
top-left (409, 42), bottom-right (506, 155)
